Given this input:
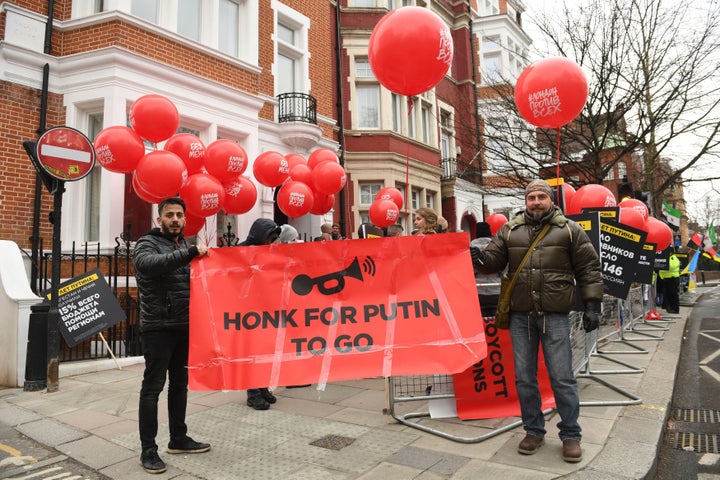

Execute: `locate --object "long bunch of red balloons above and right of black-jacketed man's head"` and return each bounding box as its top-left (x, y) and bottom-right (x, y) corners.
top-left (94, 94), bottom-right (346, 235)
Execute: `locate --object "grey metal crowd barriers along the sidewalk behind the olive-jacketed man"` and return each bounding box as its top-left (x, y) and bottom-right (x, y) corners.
top-left (385, 285), bottom-right (660, 443)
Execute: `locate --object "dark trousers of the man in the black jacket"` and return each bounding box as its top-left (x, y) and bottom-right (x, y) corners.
top-left (138, 331), bottom-right (189, 452)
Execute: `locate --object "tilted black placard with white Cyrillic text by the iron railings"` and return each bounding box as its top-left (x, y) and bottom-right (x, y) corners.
top-left (46, 269), bottom-right (125, 347)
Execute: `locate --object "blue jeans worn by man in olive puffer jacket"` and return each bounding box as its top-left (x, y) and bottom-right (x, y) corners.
top-left (510, 312), bottom-right (581, 440)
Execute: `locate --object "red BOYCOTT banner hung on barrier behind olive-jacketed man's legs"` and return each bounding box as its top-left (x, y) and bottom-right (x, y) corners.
top-left (453, 317), bottom-right (555, 420)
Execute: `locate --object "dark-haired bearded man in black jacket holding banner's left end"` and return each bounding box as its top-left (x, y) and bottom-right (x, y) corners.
top-left (134, 198), bottom-right (210, 473)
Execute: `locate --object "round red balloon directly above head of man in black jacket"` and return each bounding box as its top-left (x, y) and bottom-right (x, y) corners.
top-left (135, 150), bottom-right (187, 198)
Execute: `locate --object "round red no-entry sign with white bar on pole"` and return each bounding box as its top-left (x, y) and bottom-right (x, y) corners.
top-left (35, 127), bottom-right (95, 181)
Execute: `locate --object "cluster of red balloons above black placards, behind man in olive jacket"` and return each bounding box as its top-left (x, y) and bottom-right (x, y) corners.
top-left (565, 184), bottom-right (672, 252)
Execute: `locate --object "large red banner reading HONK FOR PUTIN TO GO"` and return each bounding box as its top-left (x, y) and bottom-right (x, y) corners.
top-left (189, 233), bottom-right (486, 390)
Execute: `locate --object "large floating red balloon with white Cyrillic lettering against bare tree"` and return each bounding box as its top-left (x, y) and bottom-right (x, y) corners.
top-left (515, 57), bottom-right (588, 128)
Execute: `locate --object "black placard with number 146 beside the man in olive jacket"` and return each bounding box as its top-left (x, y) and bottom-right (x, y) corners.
top-left (600, 220), bottom-right (647, 299)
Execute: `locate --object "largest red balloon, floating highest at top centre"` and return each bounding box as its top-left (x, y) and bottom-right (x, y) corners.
top-left (368, 7), bottom-right (453, 97)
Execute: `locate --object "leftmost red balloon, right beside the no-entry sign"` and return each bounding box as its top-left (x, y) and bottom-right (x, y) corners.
top-left (93, 125), bottom-right (145, 173)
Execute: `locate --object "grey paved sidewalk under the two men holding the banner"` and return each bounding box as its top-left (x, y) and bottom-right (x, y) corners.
top-left (0, 300), bottom-right (699, 480)
